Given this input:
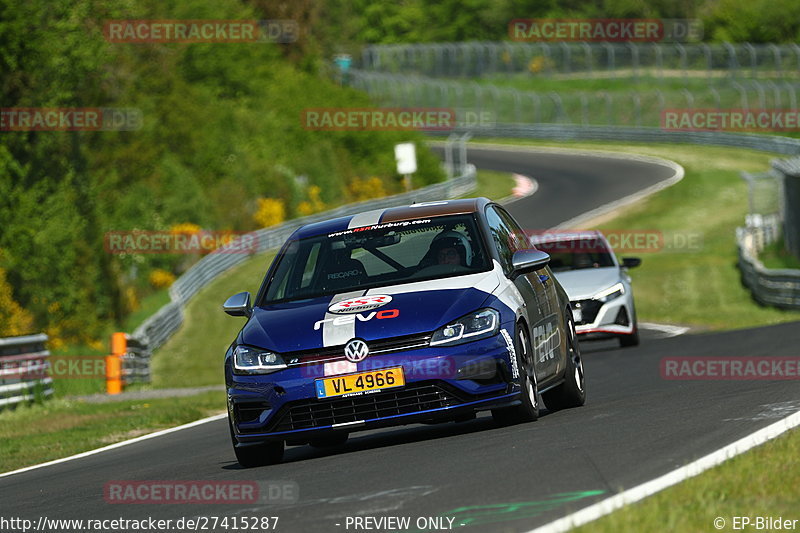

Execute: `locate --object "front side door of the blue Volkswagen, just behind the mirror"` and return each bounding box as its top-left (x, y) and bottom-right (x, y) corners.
top-left (486, 205), bottom-right (554, 382)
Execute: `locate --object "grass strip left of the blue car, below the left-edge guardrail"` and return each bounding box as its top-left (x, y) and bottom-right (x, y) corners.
top-left (0, 392), bottom-right (225, 472)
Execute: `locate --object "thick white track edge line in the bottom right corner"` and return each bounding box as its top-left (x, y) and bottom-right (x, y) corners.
top-left (528, 411), bottom-right (800, 533)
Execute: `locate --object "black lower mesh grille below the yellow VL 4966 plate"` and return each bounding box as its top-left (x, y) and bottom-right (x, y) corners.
top-left (270, 383), bottom-right (463, 431)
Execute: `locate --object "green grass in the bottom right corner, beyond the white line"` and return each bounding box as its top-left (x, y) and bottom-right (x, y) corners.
top-left (573, 429), bottom-right (800, 533)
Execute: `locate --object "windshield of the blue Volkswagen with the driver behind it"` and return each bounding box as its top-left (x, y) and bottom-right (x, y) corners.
top-left (262, 215), bottom-right (491, 304)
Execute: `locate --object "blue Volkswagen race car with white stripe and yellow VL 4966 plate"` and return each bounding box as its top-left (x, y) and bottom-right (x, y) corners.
top-left (223, 198), bottom-right (586, 467)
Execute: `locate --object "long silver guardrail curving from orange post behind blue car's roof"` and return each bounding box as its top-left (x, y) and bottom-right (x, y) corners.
top-left (129, 166), bottom-right (476, 358)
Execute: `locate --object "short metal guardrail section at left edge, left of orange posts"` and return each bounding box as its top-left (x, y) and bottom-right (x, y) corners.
top-left (0, 333), bottom-right (53, 409)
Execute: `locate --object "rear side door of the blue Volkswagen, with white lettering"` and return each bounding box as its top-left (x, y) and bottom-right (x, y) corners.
top-left (497, 207), bottom-right (564, 376)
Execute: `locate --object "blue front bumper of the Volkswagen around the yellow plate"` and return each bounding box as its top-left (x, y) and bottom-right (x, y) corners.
top-left (225, 332), bottom-right (519, 445)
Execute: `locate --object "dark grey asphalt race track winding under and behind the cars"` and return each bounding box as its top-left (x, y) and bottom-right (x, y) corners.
top-left (0, 145), bottom-right (800, 532)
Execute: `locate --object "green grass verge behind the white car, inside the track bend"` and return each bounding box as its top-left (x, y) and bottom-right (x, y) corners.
top-left (472, 140), bottom-right (800, 330)
